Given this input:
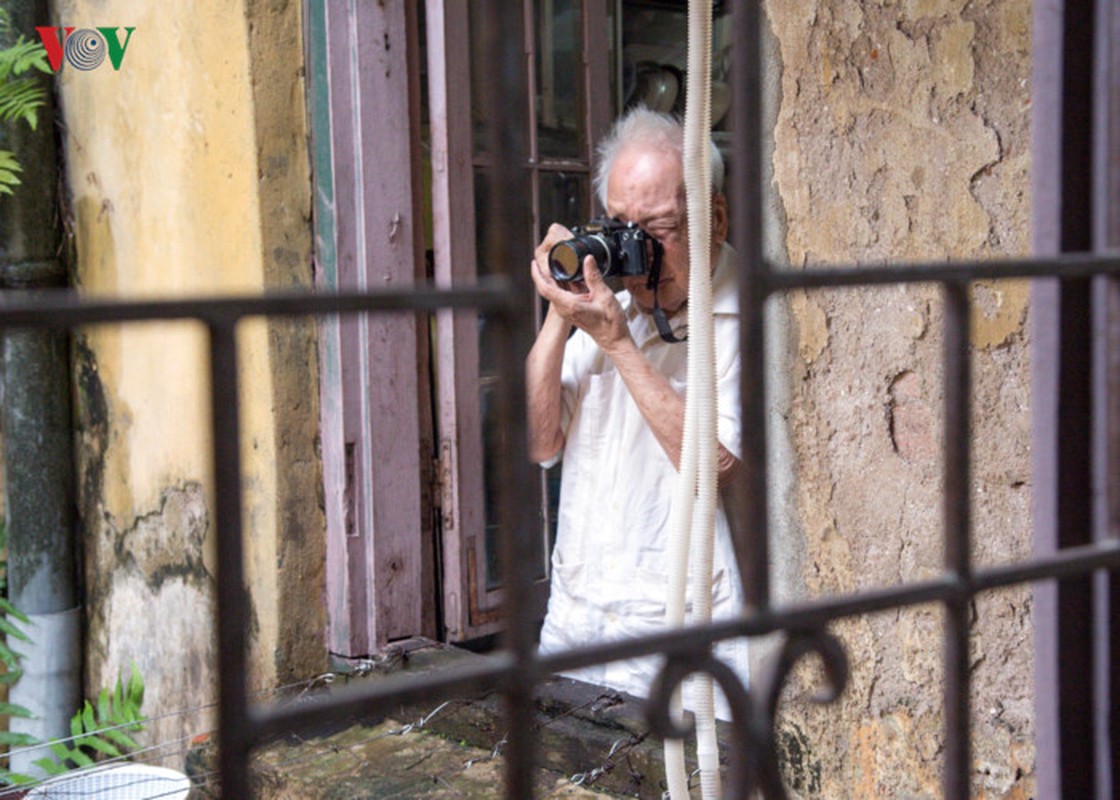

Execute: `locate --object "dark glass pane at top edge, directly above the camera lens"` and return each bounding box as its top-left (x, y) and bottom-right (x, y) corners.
top-left (535, 0), bottom-right (586, 158)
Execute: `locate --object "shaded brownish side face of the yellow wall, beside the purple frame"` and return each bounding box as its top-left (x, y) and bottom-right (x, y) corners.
top-left (246, 0), bottom-right (327, 683)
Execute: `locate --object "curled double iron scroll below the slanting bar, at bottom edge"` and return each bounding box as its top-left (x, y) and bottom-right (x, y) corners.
top-left (646, 629), bottom-right (848, 800)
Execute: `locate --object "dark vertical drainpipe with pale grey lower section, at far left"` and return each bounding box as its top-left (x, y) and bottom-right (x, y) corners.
top-left (0, 0), bottom-right (82, 774)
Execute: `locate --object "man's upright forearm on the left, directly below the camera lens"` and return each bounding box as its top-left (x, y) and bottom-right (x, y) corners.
top-left (525, 313), bottom-right (571, 463)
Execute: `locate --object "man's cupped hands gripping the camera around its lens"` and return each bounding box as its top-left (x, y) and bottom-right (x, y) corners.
top-left (532, 220), bottom-right (629, 354)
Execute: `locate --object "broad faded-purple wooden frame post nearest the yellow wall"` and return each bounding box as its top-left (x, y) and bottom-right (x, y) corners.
top-left (321, 0), bottom-right (435, 657)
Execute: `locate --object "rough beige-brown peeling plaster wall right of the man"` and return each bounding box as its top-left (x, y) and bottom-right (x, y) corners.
top-left (766, 0), bottom-right (1034, 798)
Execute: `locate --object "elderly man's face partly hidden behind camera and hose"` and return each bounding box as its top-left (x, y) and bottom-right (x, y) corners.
top-left (607, 145), bottom-right (727, 316)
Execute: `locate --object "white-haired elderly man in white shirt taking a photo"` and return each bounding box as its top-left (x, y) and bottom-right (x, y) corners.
top-left (526, 109), bottom-right (747, 716)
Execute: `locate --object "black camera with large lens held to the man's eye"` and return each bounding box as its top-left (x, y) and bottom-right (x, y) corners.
top-left (549, 216), bottom-right (662, 283)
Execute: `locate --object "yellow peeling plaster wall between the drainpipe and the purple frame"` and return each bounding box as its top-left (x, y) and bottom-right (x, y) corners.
top-left (54, 0), bottom-right (326, 761)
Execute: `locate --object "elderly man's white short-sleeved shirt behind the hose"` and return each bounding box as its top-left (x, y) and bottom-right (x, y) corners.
top-left (541, 244), bottom-right (747, 717)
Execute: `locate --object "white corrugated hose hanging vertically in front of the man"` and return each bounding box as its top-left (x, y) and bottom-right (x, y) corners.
top-left (665, 0), bottom-right (720, 800)
